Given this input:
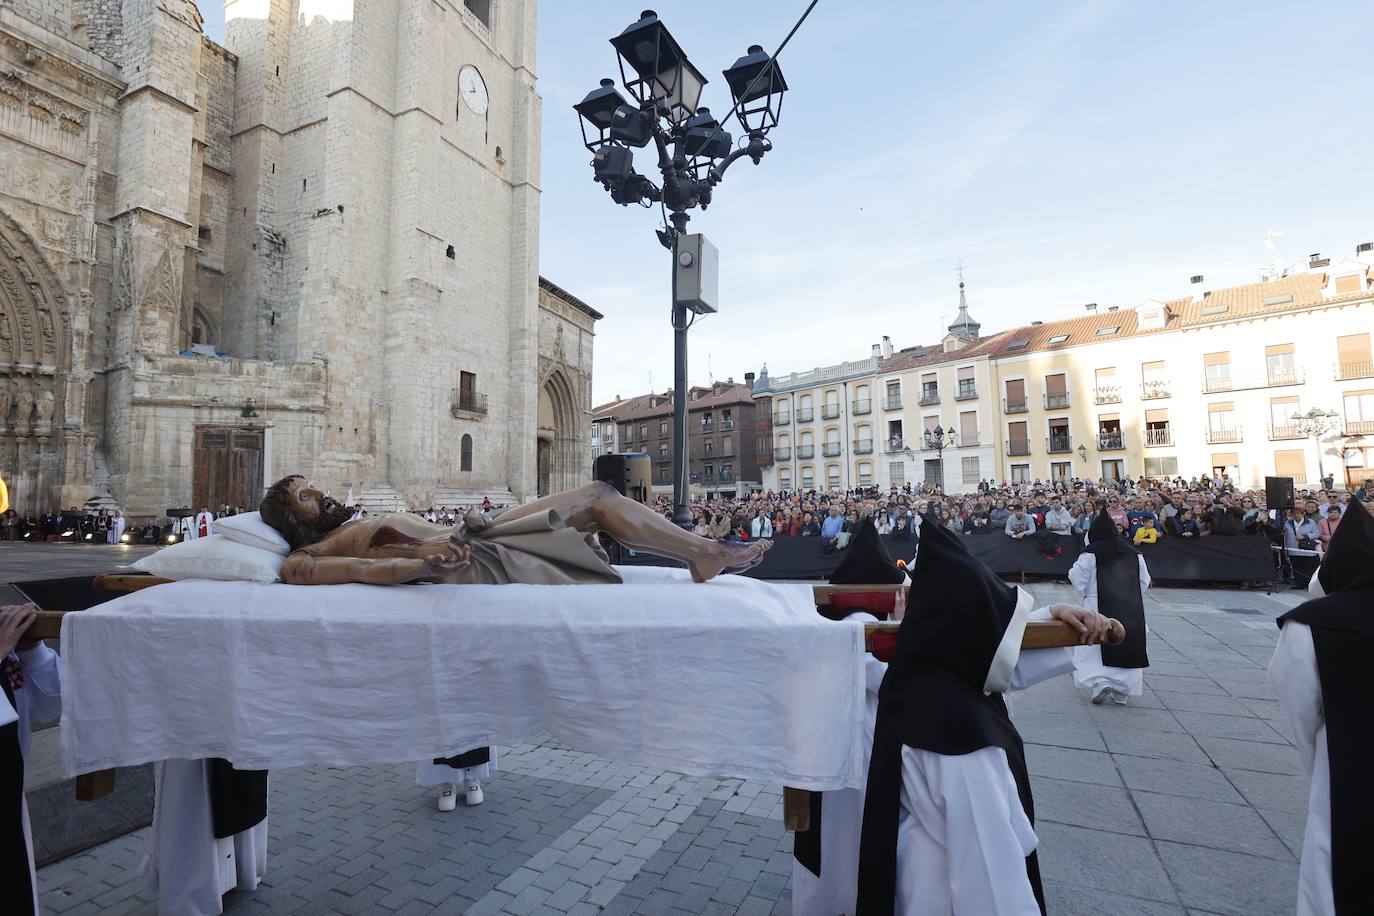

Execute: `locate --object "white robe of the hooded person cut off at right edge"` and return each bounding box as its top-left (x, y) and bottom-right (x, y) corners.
top-left (1270, 623), bottom-right (1336, 916)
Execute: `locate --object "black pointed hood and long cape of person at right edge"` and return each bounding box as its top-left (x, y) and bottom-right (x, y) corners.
top-left (1279, 504), bottom-right (1374, 916)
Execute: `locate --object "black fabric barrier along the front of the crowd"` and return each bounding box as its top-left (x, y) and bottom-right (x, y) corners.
top-left (618, 534), bottom-right (1274, 584)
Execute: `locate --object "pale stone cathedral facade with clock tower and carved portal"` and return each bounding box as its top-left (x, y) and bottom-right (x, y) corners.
top-left (0, 0), bottom-right (600, 516)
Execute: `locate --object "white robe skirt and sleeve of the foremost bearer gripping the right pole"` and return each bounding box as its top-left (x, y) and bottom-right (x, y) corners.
top-left (894, 607), bottom-right (1073, 916)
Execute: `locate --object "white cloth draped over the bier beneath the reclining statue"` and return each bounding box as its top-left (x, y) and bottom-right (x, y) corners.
top-left (62, 567), bottom-right (866, 790)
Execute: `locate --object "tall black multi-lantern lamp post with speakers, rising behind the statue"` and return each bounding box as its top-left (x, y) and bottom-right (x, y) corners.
top-left (573, 10), bottom-right (800, 527)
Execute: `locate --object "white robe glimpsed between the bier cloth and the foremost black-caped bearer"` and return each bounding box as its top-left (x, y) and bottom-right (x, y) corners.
top-left (791, 611), bottom-right (888, 916)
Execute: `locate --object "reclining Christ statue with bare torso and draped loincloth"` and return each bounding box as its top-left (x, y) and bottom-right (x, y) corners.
top-left (260, 475), bottom-right (772, 585)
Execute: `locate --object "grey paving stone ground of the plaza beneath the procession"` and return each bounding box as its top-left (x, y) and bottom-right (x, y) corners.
top-left (38, 584), bottom-right (1307, 916)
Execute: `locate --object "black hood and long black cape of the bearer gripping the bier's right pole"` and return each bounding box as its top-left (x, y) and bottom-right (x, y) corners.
top-left (859, 520), bottom-right (1044, 916)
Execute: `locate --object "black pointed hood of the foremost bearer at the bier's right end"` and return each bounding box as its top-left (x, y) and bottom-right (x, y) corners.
top-left (896, 519), bottom-right (1021, 691)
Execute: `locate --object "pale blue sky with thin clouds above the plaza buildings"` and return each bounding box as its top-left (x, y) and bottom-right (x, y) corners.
top-left (206, 0), bottom-right (1374, 402)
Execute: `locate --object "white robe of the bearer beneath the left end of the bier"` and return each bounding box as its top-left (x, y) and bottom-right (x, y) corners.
top-left (143, 759), bottom-right (267, 916)
